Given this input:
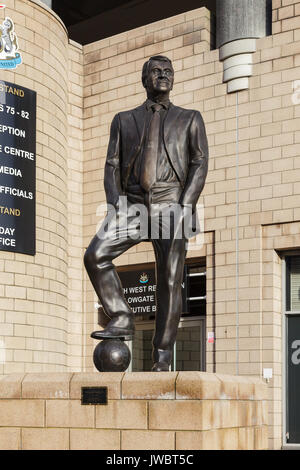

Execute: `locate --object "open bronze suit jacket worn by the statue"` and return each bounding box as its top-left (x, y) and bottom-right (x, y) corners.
top-left (104, 103), bottom-right (208, 208)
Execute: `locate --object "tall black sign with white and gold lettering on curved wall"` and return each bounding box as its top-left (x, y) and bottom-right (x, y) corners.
top-left (0, 81), bottom-right (36, 255)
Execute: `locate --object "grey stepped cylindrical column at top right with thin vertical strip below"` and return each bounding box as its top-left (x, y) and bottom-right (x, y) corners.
top-left (216, 0), bottom-right (272, 375)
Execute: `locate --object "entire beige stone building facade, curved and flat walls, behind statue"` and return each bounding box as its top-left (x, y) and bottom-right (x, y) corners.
top-left (0, 0), bottom-right (300, 448)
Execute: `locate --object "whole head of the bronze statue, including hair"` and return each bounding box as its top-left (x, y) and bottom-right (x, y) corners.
top-left (142, 55), bottom-right (174, 96)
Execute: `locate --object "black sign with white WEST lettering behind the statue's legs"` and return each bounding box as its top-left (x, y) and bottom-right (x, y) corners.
top-left (118, 268), bottom-right (187, 316)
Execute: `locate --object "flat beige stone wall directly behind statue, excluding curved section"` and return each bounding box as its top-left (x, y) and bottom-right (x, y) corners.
top-left (80, 0), bottom-right (300, 448)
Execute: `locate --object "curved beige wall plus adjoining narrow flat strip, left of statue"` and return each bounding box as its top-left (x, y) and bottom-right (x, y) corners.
top-left (0, 0), bottom-right (83, 374)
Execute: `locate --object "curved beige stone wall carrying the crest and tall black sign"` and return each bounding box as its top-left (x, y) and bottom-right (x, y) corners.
top-left (0, 0), bottom-right (68, 374)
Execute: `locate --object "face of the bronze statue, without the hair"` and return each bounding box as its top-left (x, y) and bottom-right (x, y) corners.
top-left (145, 60), bottom-right (174, 94)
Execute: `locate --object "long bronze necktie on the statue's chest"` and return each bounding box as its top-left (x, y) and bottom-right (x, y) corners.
top-left (140, 104), bottom-right (162, 191)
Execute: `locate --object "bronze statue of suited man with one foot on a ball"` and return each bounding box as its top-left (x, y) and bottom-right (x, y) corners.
top-left (84, 56), bottom-right (208, 371)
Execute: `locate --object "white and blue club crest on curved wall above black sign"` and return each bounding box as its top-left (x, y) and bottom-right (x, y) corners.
top-left (0, 17), bottom-right (22, 69)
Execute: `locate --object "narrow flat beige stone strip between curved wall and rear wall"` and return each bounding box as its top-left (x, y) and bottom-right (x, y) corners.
top-left (67, 41), bottom-right (85, 372)
